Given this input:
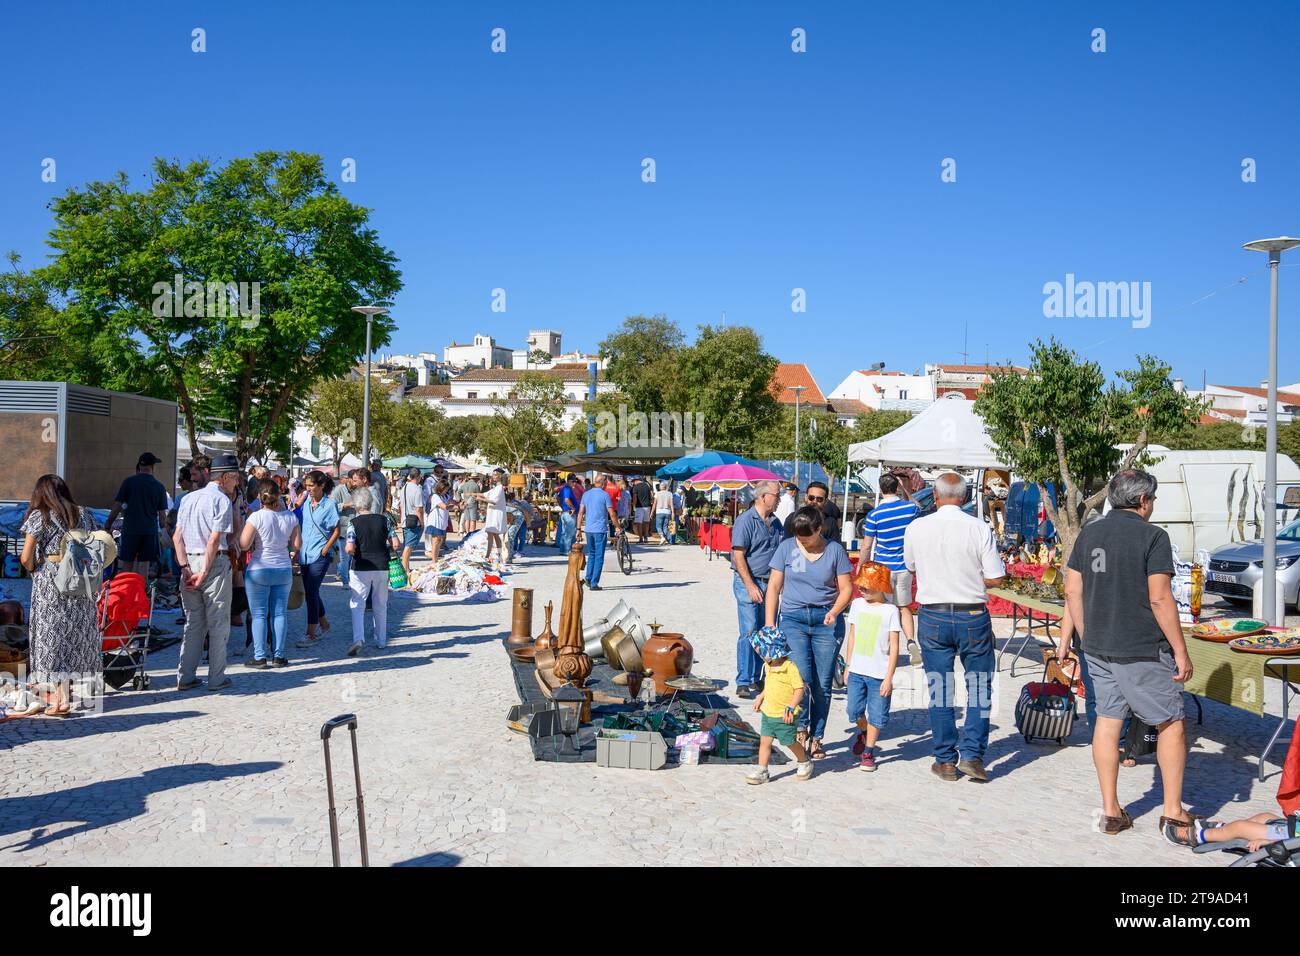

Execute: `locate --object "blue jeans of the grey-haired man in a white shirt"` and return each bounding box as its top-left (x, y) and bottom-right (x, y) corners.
top-left (917, 606), bottom-right (993, 763)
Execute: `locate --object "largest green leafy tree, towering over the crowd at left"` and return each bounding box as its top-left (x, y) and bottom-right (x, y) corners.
top-left (43, 152), bottom-right (402, 462)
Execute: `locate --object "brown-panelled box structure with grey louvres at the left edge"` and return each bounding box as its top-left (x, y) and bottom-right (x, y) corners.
top-left (0, 381), bottom-right (178, 509)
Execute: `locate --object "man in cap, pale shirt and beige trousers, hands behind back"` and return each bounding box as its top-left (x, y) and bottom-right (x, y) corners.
top-left (173, 455), bottom-right (241, 691)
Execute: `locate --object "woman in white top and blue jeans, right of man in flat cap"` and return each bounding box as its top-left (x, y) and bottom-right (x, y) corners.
top-left (239, 479), bottom-right (303, 669)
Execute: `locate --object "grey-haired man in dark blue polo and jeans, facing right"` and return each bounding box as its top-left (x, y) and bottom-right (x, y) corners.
top-left (732, 481), bottom-right (785, 700)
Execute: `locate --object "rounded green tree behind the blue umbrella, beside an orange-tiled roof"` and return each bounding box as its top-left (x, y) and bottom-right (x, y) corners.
top-left (666, 325), bottom-right (780, 455)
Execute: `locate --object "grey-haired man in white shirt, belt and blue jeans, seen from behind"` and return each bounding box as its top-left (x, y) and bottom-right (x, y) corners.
top-left (904, 472), bottom-right (1006, 783)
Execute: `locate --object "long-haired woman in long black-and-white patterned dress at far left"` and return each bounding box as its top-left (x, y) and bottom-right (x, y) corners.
top-left (22, 475), bottom-right (104, 717)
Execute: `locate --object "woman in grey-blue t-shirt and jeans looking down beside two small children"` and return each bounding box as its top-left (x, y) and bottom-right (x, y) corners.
top-left (767, 506), bottom-right (853, 760)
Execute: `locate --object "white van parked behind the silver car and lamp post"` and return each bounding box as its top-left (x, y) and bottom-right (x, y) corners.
top-left (1106, 446), bottom-right (1300, 561)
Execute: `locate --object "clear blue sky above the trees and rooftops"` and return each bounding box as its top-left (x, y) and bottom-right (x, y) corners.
top-left (0, 0), bottom-right (1300, 390)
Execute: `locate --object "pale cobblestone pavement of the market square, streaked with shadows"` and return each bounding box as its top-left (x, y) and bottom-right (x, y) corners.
top-left (0, 546), bottom-right (1282, 866)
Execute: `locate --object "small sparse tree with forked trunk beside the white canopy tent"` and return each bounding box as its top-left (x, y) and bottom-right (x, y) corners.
top-left (975, 338), bottom-right (1200, 558)
